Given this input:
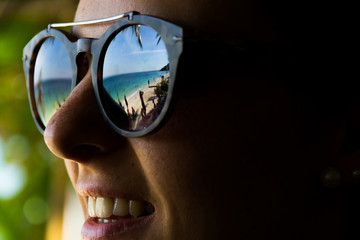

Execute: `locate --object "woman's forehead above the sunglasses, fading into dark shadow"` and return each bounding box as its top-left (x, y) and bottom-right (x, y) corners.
top-left (73, 0), bottom-right (276, 40)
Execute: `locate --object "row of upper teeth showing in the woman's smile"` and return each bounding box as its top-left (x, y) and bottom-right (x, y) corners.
top-left (88, 197), bottom-right (154, 218)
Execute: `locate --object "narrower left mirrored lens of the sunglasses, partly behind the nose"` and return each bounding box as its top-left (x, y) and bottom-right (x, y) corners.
top-left (34, 37), bottom-right (72, 126)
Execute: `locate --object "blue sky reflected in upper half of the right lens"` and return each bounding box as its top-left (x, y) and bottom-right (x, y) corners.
top-left (103, 25), bottom-right (169, 78)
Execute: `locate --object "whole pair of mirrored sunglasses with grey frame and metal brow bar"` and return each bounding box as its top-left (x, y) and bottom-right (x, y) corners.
top-left (23, 12), bottom-right (282, 137)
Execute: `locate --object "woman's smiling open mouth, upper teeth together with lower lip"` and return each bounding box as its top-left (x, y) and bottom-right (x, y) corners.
top-left (82, 196), bottom-right (155, 239)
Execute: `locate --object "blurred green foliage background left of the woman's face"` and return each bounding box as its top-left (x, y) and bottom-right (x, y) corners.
top-left (0, 0), bottom-right (77, 240)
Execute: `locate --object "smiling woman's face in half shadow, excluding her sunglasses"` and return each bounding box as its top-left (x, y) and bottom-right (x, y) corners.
top-left (44, 0), bottom-right (344, 240)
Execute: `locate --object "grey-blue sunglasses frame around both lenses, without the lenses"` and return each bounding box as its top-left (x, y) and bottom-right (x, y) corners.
top-left (23, 14), bottom-right (183, 137)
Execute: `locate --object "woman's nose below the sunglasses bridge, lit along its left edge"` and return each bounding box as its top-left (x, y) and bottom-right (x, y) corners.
top-left (44, 71), bottom-right (125, 161)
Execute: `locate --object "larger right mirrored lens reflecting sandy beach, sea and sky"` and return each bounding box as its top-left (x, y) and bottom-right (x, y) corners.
top-left (103, 25), bottom-right (170, 131)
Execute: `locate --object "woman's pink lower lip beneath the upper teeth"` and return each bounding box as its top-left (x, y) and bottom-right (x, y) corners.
top-left (81, 215), bottom-right (151, 240)
